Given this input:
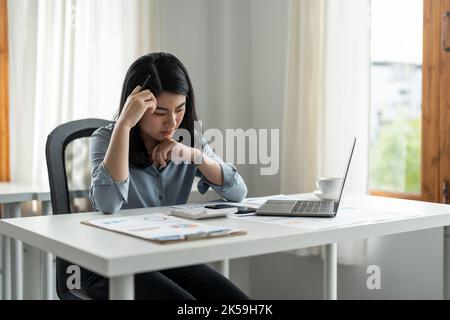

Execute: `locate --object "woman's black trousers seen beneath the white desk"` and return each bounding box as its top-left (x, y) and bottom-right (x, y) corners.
top-left (83, 264), bottom-right (248, 300)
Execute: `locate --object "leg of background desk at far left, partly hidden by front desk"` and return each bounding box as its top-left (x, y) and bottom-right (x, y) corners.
top-left (9, 202), bottom-right (23, 300)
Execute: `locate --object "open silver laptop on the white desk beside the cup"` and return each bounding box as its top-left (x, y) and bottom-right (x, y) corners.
top-left (255, 138), bottom-right (356, 218)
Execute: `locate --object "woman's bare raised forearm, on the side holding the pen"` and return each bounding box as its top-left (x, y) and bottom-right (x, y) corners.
top-left (103, 123), bottom-right (131, 182)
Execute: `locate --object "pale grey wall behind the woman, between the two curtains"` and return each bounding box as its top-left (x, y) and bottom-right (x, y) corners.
top-left (163, 0), bottom-right (288, 196)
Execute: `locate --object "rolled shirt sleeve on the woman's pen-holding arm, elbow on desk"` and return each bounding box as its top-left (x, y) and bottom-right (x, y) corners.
top-left (89, 127), bottom-right (130, 213)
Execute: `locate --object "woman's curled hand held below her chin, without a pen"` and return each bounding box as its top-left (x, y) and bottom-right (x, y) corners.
top-left (151, 138), bottom-right (200, 168)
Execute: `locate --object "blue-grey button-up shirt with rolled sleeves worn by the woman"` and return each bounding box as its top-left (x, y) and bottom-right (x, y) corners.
top-left (89, 124), bottom-right (247, 213)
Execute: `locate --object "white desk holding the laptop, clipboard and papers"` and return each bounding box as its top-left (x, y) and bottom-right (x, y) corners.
top-left (0, 195), bottom-right (450, 299)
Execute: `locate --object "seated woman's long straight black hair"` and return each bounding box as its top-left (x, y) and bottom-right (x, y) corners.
top-left (115, 52), bottom-right (197, 168)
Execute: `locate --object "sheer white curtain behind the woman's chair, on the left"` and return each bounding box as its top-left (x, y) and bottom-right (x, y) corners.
top-left (8, 0), bottom-right (162, 184)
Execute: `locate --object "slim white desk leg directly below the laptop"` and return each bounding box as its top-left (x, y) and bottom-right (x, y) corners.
top-left (323, 243), bottom-right (337, 300)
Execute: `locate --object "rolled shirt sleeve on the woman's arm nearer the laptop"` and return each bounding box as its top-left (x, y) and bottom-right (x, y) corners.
top-left (196, 138), bottom-right (247, 202)
